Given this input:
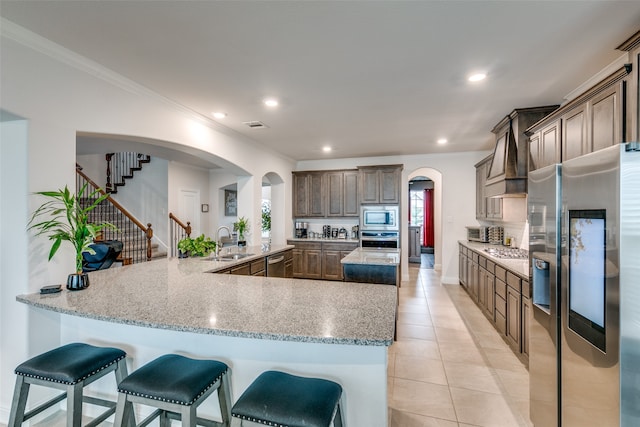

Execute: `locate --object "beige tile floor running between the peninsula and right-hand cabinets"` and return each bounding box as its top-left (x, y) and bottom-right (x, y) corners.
top-left (388, 263), bottom-right (532, 427)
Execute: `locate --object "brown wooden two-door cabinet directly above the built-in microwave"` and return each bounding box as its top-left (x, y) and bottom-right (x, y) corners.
top-left (358, 165), bottom-right (402, 204)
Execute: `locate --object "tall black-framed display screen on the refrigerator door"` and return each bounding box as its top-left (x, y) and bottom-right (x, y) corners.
top-left (569, 209), bottom-right (606, 351)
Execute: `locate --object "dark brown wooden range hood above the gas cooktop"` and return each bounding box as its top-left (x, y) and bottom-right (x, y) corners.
top-left (485, 105), bottom-right (558, 198)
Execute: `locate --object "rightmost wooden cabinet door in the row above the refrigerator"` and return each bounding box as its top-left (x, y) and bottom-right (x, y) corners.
top-left (589, 85), bottom-right (622, 151)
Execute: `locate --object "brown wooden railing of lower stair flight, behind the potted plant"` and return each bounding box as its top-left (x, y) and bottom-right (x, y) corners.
top-left (76, 165), bottom-right (153, 264)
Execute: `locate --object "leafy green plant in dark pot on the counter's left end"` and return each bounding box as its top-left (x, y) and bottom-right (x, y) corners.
top-left (28, 184), bottom-right (116, 290)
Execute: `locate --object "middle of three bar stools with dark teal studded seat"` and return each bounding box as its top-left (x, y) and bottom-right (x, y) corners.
top-left (114, 354), bottom-right (231, 427)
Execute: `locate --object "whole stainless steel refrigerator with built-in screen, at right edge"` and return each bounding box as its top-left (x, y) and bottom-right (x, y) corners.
top-left (529, 143), bottom-right (640, 427)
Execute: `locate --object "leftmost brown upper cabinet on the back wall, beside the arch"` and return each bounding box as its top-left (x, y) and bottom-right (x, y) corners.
top-left (293, 171), bottom-right (325, 218)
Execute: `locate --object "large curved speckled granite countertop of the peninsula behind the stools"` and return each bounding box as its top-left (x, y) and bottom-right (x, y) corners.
top-left (16, 247), bottom-right (397, 346)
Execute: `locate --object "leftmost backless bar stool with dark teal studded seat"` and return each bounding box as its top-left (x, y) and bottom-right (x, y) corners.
top-left (9, 343), bottom-right (127, 427)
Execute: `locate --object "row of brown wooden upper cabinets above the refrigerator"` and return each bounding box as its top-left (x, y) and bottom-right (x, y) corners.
top-left (526, 65), bottom-right (631, 170)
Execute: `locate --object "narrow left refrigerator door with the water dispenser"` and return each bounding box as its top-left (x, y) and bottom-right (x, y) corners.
top-left (528, 165), bottom-right (562, 427)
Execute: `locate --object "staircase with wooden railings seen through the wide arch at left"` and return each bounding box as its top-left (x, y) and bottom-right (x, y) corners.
top-left (76, 153), bottom-right (167, 265)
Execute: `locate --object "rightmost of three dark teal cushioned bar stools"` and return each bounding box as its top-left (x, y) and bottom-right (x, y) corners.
top-left (231, 371), bottom-right (344, 427)
